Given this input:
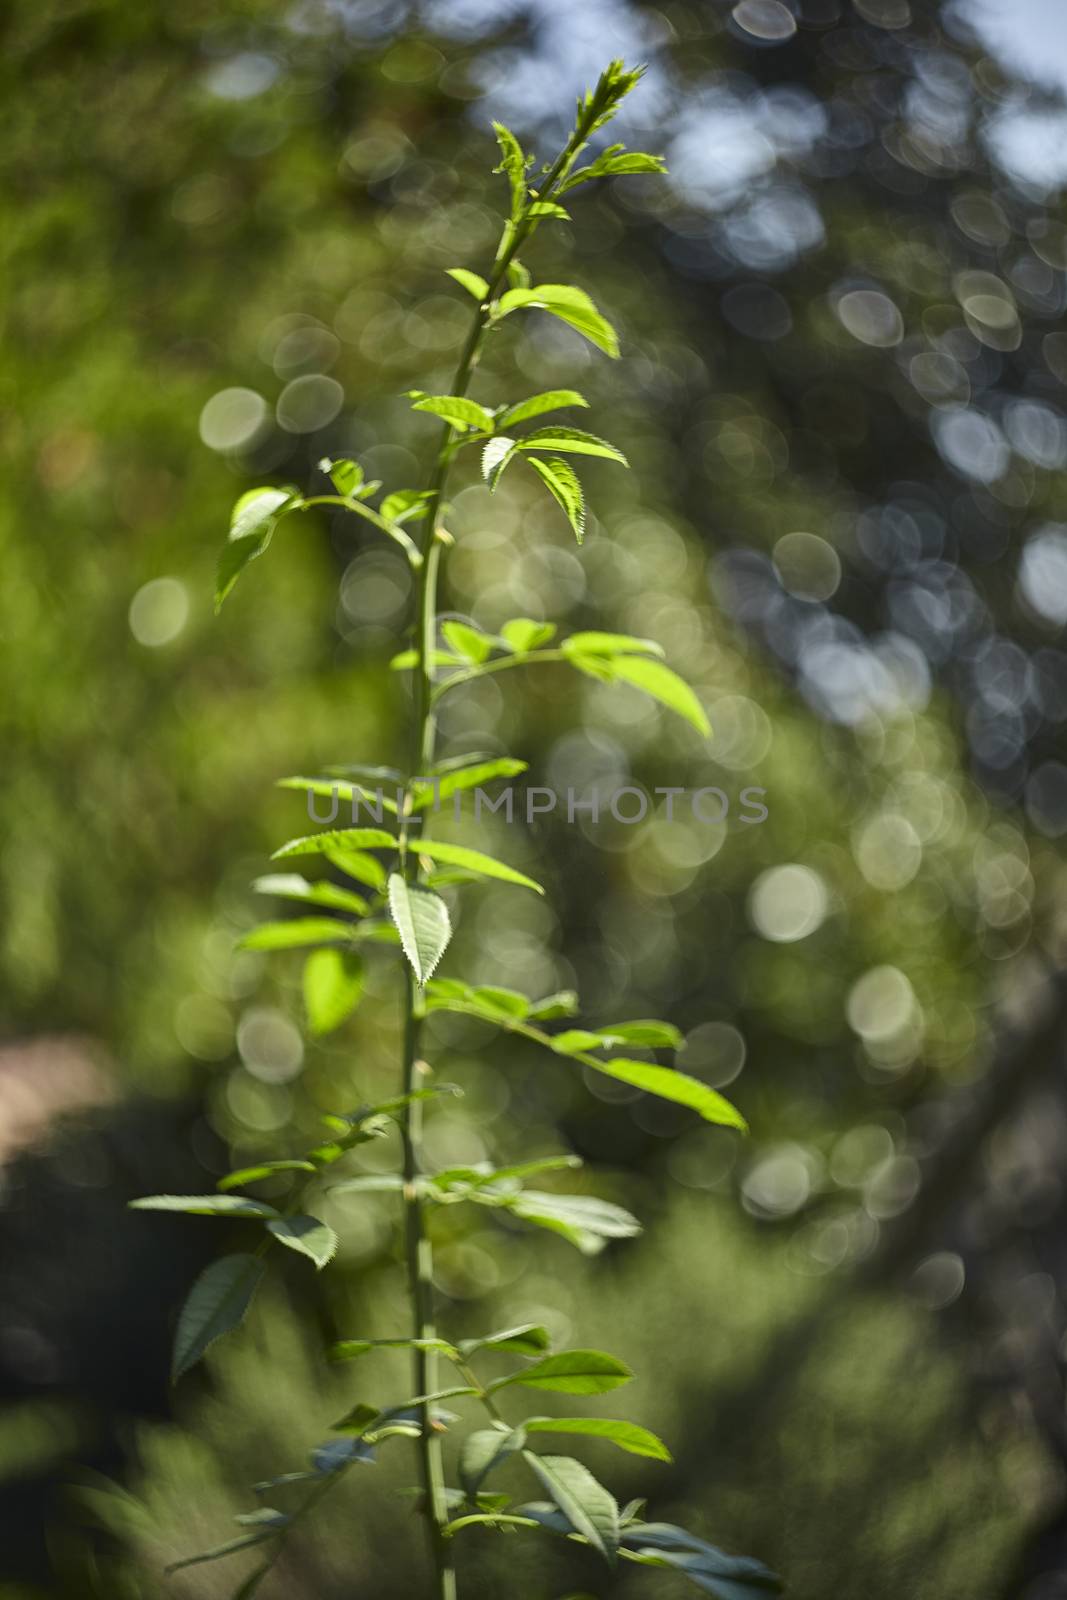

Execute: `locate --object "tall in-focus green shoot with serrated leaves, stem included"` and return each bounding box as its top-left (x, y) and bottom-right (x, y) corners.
top-left (133, 61), bottom-right (779, 1600)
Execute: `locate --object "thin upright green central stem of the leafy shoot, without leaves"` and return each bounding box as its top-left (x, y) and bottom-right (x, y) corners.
top-left (400, 106), bottom-right (604, 1600)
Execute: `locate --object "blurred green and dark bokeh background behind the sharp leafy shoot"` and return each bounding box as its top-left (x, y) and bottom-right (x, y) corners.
top-left (0, 0), bottom-right (1067, 1600)
